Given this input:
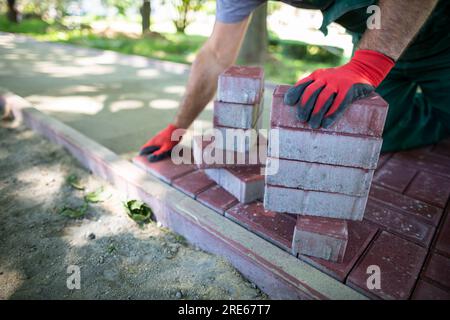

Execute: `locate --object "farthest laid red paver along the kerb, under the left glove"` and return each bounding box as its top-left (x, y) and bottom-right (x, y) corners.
top-left (133, 156), bottom-right (197, 184)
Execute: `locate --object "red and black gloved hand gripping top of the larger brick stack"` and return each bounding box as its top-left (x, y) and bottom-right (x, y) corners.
top-left (284, 50), bottom-right (394, 129)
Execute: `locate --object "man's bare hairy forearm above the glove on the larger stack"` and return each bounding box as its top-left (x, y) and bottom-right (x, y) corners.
top-left (359, 0), bottom-right (438, 61)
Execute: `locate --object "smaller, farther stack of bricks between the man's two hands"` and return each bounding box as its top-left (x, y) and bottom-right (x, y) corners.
top-left (193, 66), bottom-right (267, 203)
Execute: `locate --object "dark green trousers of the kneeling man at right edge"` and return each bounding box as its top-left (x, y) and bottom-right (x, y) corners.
top-left (376, 48), bottom-right (450, 152)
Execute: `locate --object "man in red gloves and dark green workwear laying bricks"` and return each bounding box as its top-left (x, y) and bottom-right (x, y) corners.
top-left (140, 0), bottom-right (450, 162)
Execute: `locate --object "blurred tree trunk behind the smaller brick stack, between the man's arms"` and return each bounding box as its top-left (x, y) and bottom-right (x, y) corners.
top-left (238, 2), bottom-right (268, 65)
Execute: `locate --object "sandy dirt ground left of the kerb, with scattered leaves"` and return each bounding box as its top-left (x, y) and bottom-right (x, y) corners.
top-left (0, 124), bottom-right (267, 299)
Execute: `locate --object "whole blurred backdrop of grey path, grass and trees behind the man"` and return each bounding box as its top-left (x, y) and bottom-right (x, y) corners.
top-left (0, 0), bottom-right (352, 158)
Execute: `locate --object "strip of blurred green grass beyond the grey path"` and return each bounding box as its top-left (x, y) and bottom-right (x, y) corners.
top-left (0, 16), bottom-right (342, 83)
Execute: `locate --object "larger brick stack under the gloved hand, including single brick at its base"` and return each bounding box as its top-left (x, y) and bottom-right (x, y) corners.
top-left (264, 86), bottom-right (387, 262)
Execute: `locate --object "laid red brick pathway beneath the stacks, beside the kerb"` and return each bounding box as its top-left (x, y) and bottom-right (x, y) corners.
top-left (134, 140), bottom-right (450, 299)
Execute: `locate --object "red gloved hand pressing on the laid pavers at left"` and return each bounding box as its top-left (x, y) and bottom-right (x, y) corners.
top-left (139, 124), bottom-right (181, 162)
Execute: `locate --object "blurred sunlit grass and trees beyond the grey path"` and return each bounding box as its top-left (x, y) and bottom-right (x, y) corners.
top-left (0, 0), bottom-right (352, 83)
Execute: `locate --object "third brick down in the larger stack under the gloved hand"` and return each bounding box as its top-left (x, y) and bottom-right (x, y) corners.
top-left (266, 157), bottom-right (373, 196)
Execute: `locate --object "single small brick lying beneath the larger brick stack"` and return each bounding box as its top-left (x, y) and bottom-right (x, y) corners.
top-left (291, 216), bottom-right (348, 262)
